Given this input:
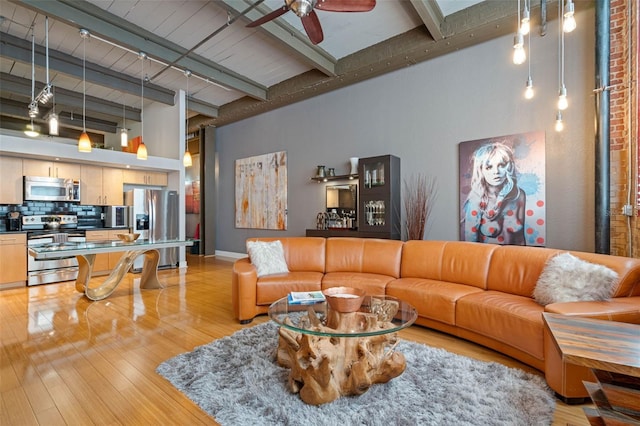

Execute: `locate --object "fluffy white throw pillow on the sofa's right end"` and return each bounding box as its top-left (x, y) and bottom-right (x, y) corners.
top-left (533, 253), bottom-right (618, 306)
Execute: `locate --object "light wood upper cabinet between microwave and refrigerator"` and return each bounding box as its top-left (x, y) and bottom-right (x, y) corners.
top-left (80, 165), bottom-right (124, 206)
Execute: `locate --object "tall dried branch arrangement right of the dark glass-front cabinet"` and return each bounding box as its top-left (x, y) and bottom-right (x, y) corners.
top-left (403, 173), bottom-right (438, 240)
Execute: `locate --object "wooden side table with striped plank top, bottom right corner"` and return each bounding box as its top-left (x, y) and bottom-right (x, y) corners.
top-left (543, 313), bottom-right (640, 426)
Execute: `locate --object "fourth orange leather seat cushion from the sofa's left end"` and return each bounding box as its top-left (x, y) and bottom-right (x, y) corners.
top-left (456, 290), bottom-right (544, 360)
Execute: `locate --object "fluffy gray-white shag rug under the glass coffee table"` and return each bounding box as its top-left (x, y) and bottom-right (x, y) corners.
top-left (157, 322), bottom-right (555, 426)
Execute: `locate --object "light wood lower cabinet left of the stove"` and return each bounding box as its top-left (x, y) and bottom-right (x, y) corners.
top-left (0, 233), bottom-right (28, 288)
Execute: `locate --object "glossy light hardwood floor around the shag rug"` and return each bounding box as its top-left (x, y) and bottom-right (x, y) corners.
top-left (0, 256), bottom-right (589, 426)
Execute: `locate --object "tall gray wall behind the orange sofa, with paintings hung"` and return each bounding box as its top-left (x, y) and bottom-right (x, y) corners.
top-left (216, 9), bottom-right (595, 253)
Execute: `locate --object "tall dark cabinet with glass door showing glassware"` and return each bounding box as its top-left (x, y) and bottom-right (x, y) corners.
top-left (358, 155), bottom-right (402, 240)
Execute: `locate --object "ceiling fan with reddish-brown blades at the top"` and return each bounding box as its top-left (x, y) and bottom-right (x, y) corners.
top-left (247, 0), bottom-right (376, 44)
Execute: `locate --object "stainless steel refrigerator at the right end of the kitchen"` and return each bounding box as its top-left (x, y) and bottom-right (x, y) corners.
top-left (124, 189), bottom-right (179, 271)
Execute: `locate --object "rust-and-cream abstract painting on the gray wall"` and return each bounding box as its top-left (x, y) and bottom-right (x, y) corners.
top-left (235, 151), bottom-right (287, 230)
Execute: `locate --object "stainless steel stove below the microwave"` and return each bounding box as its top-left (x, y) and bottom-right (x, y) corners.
top-left (22, 213), bottom-right (86, 286)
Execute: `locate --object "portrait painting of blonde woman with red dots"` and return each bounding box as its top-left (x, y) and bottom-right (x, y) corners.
top-left (460, 132), bottom-right (545, 246)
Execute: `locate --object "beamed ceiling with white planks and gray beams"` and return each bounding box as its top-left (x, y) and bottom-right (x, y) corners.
top-left (0, 0), bottom-right (568, 133)
